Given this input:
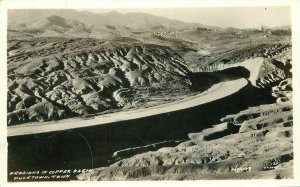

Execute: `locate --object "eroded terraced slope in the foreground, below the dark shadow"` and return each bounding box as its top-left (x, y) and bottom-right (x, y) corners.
top-left (78, 78), bottom-right (293, 180)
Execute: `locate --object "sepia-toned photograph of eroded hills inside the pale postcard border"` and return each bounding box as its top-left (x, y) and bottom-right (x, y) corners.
top-left (1, 0), bottom-right (295, 183)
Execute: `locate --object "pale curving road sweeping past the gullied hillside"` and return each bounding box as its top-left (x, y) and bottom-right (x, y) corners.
top-left (7, 78), bottom-right (248, 137)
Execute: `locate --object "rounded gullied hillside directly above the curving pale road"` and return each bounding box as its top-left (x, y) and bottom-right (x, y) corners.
top-left (8, 38), bottom-right (199, 125)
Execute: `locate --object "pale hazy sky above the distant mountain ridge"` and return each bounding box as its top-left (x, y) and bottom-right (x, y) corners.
top-left (80, 6), bottom-right (291, 28)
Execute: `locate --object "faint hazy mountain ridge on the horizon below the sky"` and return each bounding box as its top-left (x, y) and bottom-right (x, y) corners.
top-left (8, 9), bottom-right (203, 29)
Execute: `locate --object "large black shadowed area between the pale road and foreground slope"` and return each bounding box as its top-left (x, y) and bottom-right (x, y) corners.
top-left (8, 66), bottom-right (274, 180)
